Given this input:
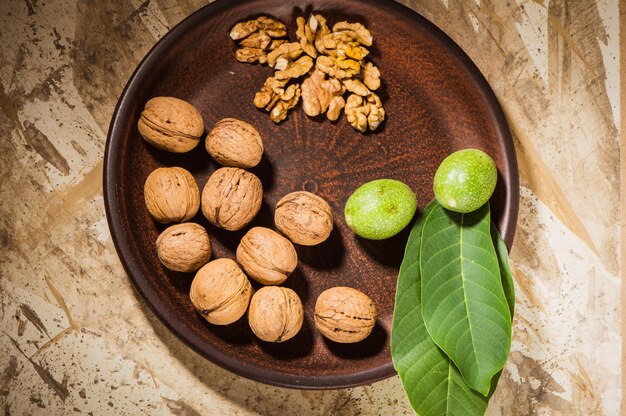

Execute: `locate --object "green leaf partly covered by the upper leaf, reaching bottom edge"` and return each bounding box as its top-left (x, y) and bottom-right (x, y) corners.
top-left (391, 202), bottom-right (487, 416)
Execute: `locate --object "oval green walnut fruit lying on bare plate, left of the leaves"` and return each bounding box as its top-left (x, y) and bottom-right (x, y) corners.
top-left (344, 179), bottom-right (417, 240)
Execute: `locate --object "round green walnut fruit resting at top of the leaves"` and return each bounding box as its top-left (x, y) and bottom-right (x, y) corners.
top-left (433, 149), bottom-right (498, 213)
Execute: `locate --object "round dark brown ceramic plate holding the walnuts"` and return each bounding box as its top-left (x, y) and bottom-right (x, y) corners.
top-left (104, 0), bottom-right (519, 389)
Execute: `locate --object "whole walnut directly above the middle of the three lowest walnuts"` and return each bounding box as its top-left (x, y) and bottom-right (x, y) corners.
top-left (237, 227), bottom-right (298, 285)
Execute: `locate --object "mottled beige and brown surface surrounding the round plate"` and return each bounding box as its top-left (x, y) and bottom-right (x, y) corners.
top-left (0, 0), bottom-right (622, 415)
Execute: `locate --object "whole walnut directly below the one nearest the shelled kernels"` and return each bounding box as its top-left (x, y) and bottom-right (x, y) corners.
top-left (202, 168), bottom-right (263, 231)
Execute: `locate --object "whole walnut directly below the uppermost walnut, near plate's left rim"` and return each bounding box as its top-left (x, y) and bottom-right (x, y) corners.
top-left (143, 167), bottom-right (200, 224)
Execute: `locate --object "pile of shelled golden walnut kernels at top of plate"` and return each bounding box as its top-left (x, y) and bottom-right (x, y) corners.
top-left (230, 14), bottom-right (385, 132)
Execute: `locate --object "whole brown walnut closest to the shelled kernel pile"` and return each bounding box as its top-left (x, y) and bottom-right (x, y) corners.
top-left (206, 118), bottom-right (263, 168)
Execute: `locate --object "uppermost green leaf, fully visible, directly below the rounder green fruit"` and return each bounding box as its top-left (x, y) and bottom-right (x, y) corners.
top-left (420, 204), bottom-right (511, 396)
